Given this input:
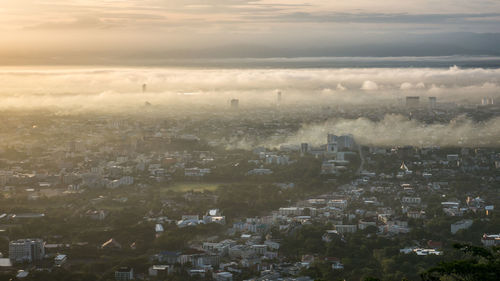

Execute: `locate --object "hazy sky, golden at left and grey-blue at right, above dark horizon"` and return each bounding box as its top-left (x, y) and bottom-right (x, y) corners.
top-left (0, 0), bottom-right (500, 65)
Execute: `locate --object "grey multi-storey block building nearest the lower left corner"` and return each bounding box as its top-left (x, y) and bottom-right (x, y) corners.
top-left (9, 239), bottom-right (45, 263)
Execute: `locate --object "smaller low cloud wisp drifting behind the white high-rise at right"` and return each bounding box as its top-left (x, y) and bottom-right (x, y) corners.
top-left (230, 114), bottom-right (500, 148)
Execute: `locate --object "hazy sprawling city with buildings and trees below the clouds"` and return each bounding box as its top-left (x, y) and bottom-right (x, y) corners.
top-left (0, 95), bottom-right (500, 281)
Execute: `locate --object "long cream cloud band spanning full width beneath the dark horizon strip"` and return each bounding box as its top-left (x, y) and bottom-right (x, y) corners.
top-left (0, 67), bottom-right (500, 111)
